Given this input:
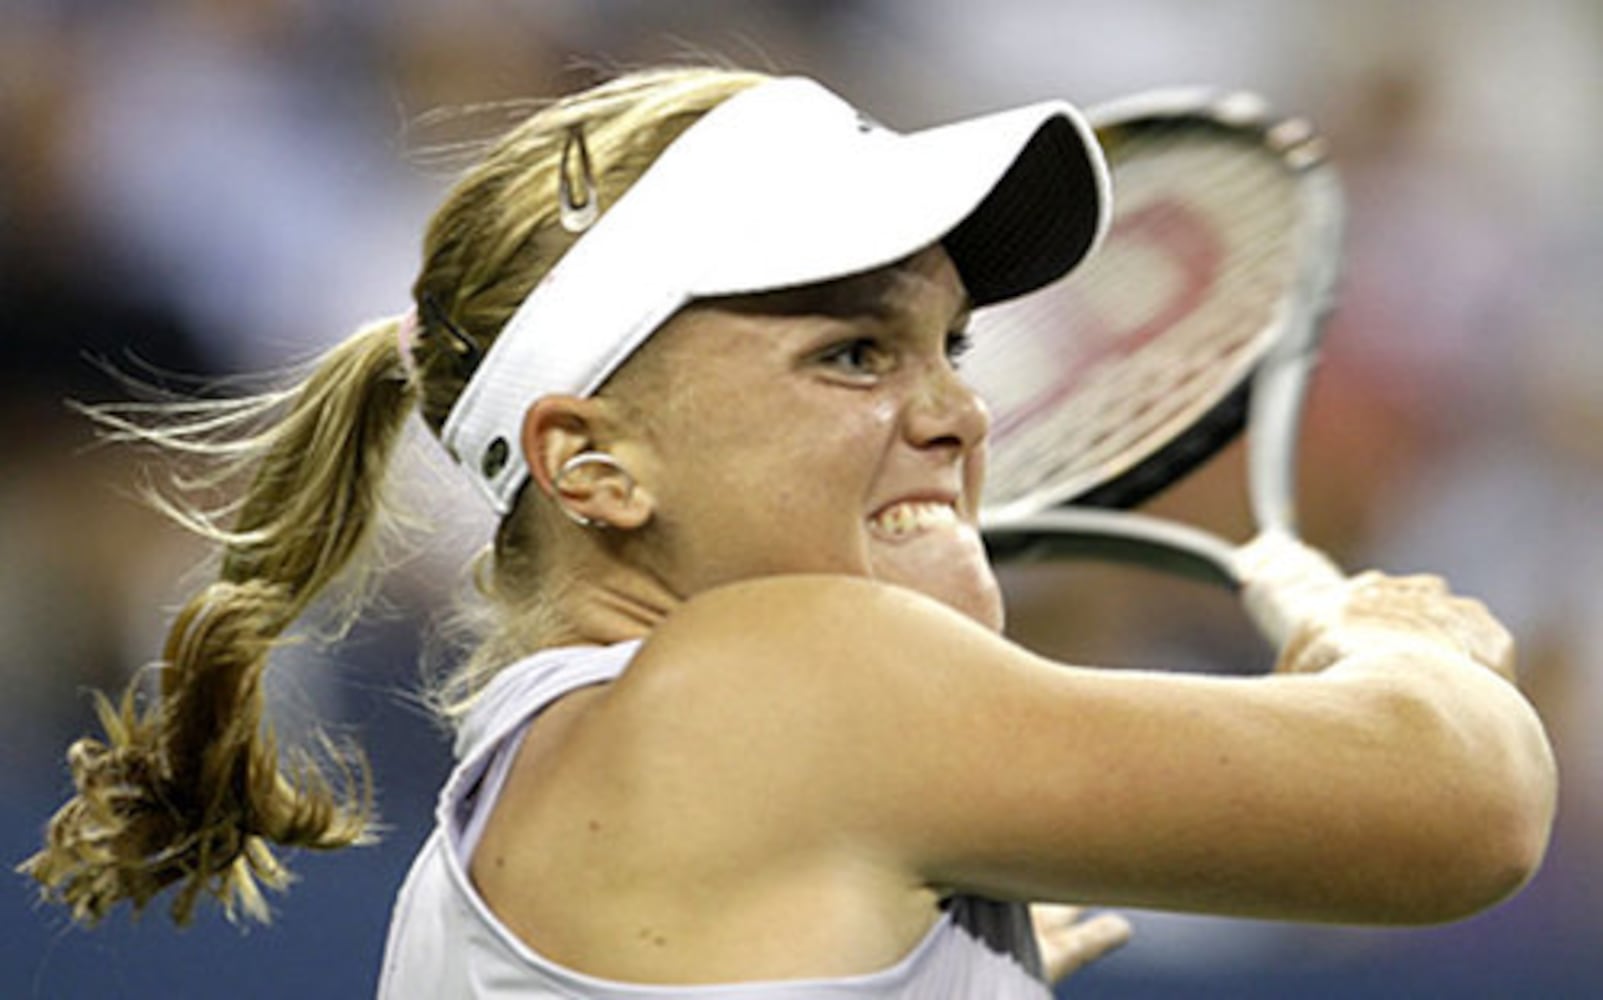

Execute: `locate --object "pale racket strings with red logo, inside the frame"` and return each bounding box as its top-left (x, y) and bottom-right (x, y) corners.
top-left (967, 125), bottom-right (1297, 511)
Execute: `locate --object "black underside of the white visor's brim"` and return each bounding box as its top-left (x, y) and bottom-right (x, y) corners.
top-left (941, 115), bottom-right (1101, 306)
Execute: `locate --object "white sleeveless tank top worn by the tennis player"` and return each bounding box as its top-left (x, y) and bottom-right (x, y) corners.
top-left (378, 641), bottom-right (1052, 1000)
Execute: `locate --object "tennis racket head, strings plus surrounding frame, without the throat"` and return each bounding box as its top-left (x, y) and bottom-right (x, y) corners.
top-left (965, 88), bottom-right (1340, 528)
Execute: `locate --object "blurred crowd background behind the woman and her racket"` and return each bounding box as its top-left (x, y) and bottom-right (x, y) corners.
top-left (0, 0), bottom-right (1603, 998)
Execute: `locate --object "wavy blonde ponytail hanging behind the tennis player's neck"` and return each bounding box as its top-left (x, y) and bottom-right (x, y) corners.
top-left (21, 321), bottom-right (417, 923)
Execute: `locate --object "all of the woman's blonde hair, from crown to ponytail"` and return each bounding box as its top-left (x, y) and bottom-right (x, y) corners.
top-left (21, 67), bottom-right (763, 923)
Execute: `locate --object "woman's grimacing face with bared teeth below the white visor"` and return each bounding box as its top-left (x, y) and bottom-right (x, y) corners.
top-left (602, 248), bottom-right (1002, 628)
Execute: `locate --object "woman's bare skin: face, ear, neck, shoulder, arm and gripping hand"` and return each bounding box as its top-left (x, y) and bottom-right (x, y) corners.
top-left (471, 250), bottom-right (1553, 982)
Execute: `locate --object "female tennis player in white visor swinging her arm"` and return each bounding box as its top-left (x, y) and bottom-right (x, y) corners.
top-left (27, 69), bottom-right (1555, 998)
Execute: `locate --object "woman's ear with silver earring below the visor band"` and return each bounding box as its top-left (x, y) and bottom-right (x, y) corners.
top-left (521, 396), bottom-right (654, 530)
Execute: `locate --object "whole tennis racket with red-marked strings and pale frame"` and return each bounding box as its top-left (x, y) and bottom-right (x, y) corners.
top-left (965, 90), bottom-right (1343, 646)
